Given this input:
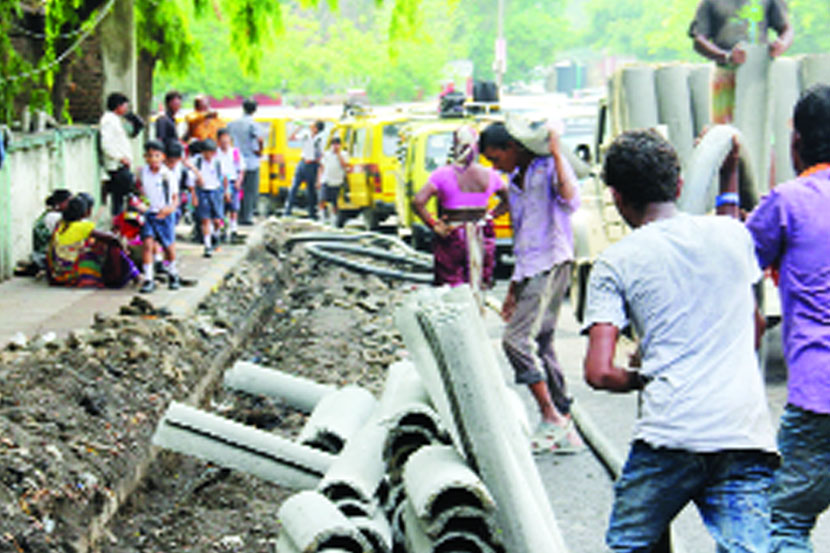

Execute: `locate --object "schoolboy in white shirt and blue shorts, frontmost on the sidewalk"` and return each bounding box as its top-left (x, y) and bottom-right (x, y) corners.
top-left (135, 140), bottom-right (181, 294)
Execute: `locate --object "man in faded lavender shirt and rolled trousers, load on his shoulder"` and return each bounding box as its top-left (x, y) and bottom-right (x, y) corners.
top-left (480, 121), bottom-right (583, 452)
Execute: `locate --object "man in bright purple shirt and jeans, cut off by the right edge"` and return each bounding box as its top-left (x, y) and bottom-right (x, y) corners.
top-left (747, 85), bottom-right (830, 552)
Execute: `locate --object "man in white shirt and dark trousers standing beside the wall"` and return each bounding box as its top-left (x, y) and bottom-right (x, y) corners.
top-left (99, 92), bottom-right (134, 217)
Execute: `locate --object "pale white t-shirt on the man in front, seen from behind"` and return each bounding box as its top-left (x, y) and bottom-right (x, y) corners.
top-left (585, 214), bottom-right (775, 452)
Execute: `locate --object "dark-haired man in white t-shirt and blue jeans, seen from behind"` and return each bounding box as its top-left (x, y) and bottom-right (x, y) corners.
top-left (585, 131), bottom-right (777, 553)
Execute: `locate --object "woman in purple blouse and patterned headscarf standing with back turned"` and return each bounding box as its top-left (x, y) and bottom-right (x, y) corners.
top-left (412, 126), bottom-right (508, 288)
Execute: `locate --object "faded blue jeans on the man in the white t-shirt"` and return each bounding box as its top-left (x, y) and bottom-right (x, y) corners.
top-left (606, 440), bottom-right (776, 553)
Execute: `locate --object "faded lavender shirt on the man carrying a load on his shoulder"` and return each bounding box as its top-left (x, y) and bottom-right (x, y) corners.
top-left (510, 156), bottom-right (579, 281)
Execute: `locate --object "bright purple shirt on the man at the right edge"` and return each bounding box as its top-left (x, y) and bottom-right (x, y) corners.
top-left (747, 169), bottom-right (830, 414)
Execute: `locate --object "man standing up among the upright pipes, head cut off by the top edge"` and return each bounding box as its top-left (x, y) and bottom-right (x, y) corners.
top-left (689, 0), bottom-right (793, 124)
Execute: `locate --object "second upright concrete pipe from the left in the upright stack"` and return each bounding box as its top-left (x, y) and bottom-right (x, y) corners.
top-left (654, 64), bottom-right (695, 166)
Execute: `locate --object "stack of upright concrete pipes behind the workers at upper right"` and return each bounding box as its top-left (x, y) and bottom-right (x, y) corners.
top-left (609, 51), bottom-right (830, 207)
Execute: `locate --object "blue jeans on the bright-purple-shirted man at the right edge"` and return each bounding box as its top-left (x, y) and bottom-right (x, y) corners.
top-left (770, 405), bottom-right (830, 553)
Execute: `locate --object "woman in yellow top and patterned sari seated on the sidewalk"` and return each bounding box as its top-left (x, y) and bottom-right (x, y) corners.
top-left (46, 197), bottom-right (139, 288)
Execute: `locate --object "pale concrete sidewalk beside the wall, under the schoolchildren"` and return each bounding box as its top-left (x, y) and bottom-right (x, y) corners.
top-left (0, 219), bottom-right (265, 347)
